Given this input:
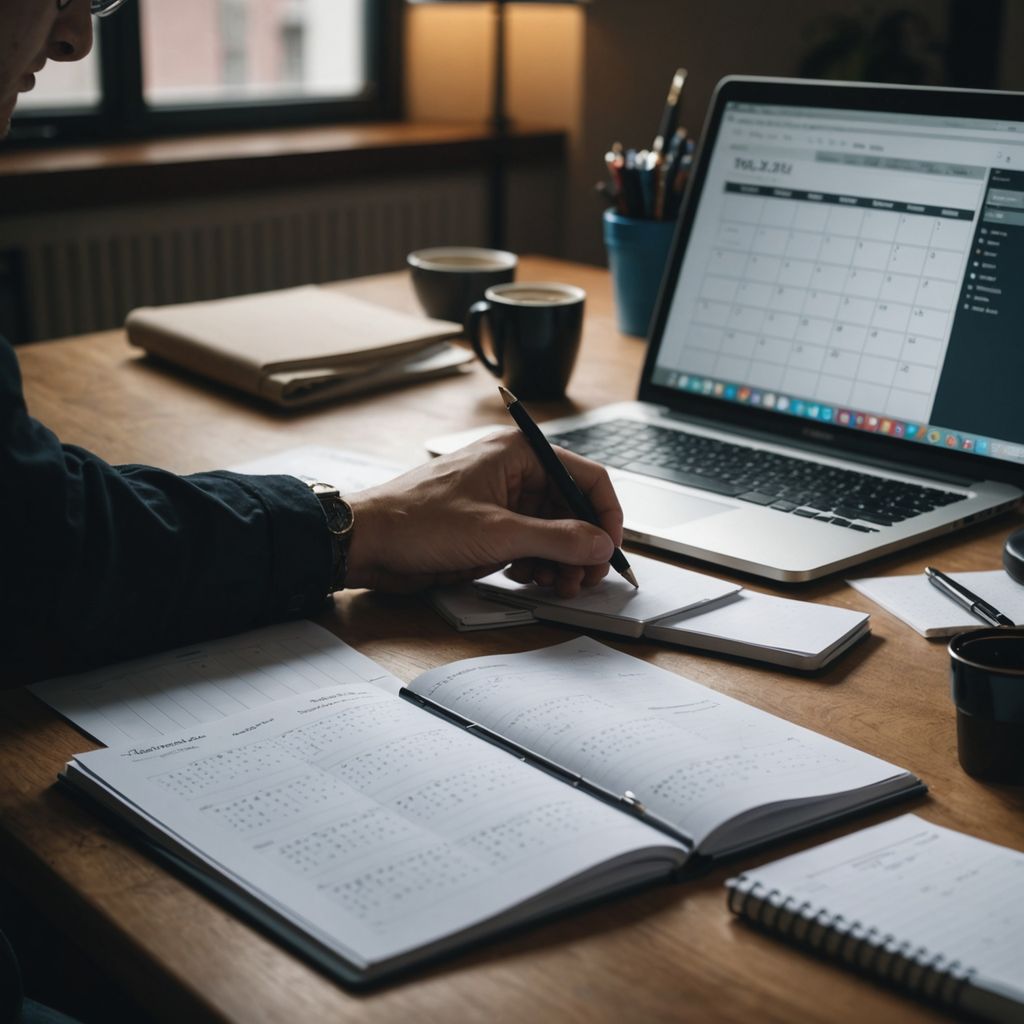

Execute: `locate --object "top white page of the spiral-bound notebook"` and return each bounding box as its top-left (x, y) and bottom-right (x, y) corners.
top-left (743, 814), bottom-right (1024, 993)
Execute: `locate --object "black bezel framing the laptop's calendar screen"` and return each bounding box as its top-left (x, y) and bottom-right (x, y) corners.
top-left (637, 76), bottom-right (1024, 485)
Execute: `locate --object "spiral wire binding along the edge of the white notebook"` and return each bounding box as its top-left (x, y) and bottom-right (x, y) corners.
top-left (726, 874), bottom-right (975, 1008)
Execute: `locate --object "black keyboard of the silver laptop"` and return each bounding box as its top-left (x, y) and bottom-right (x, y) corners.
top-left (548, 420), bottom-right (964, 532)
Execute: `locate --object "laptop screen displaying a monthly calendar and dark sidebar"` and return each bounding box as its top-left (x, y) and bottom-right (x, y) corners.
top-left (647, 90), bottom-right (1024, 464)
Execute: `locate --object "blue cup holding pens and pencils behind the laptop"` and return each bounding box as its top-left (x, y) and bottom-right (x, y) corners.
top-left (604, 210), bottom-right (676, 338)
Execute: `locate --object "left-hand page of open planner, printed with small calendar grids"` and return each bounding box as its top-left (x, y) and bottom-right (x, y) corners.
top-left (75, 683), bottom-right (681, 963)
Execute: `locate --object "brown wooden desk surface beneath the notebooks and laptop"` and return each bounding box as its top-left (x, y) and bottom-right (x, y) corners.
top-left (0, 259), bottom-right (1024, 1024)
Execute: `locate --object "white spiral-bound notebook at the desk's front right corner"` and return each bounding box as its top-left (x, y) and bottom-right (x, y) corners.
top-left (726, 814), bottom-right (1024, 1022)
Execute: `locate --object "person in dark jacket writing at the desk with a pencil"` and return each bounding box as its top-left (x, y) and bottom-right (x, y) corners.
top-left (0, 0), bottom-right (622, 683)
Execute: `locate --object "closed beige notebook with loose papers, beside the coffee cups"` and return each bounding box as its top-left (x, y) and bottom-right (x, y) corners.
top-left (125, 285), bottom-right (471, 406)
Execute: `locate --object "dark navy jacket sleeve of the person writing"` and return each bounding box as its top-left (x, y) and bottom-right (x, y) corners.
top-left (0, 338), bottom-right (331, 684)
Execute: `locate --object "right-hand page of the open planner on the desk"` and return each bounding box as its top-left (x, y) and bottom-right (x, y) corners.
top-left (409, 637), bottom-right (905, 852)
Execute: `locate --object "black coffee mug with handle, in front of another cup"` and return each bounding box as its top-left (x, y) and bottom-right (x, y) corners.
top-left (466, 282), bottom-right (587, 399)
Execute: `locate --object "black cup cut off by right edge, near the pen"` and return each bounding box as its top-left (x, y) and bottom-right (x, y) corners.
top-left (949, 626), bottom-right (1024, 783)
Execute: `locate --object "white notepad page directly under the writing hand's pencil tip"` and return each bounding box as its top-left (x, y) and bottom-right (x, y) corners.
top-left (476, 554), bottom-right (739, 628)
